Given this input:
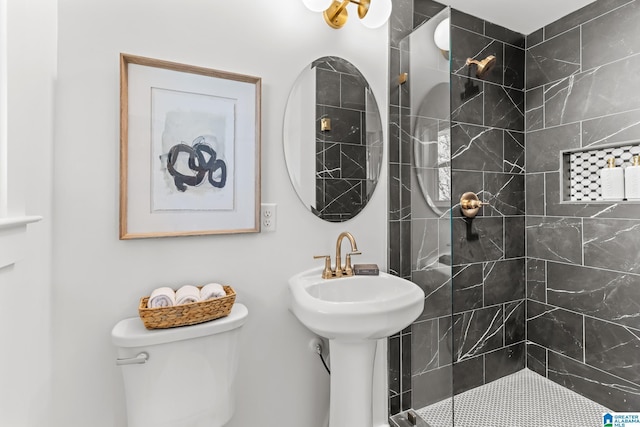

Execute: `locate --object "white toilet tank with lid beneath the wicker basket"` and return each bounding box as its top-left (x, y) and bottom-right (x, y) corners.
top-left (111, 303), bottom-right (248, 427)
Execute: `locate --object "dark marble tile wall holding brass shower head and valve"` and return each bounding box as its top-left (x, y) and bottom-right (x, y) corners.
top-left (451, 10), bottom-right (527, 404)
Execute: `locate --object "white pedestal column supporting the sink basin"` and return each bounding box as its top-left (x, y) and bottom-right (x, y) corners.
top-left (329, 340), bottom-right (377, 427)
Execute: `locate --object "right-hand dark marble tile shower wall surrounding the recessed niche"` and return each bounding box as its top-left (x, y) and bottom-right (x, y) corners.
top-left (525, 0), bottom-right (640, 411)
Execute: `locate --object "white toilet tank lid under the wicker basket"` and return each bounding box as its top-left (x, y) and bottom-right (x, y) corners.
top-left (111, 303), bottom-right (249, 347)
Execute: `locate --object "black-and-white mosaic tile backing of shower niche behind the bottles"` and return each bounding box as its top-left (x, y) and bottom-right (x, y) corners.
top-left (563, 145), bottom-right (640, 202)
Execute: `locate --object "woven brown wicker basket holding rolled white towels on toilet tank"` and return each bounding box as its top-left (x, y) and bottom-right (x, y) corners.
top-left (138, 285), bottom-right (236, 329)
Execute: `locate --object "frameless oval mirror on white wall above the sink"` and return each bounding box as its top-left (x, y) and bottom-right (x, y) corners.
top-left (283, 56), bottom-right (383, 222)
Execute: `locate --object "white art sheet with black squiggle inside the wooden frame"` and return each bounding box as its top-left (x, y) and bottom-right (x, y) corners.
top-left (150, 87), bottom-right (236, 212)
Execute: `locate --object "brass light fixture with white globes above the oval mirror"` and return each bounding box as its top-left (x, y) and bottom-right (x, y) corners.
top-left (302, 0), bottom-right (391, 29)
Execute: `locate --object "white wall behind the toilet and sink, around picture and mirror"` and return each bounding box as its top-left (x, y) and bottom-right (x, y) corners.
top-left (50, 0), bottom-right (388, 427)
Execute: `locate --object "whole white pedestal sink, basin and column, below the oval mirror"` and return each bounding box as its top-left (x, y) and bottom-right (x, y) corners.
top-left (289, 268), bottom-right (424, 427)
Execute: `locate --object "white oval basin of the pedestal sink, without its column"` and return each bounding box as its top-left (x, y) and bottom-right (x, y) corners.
top-left (289, 268), bottom-right (424, 340)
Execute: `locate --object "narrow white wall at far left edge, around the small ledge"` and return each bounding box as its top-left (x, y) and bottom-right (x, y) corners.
top-left (0, 0), bottom-right (57, 427)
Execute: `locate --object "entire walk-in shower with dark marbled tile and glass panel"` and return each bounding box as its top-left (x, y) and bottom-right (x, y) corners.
top-left (390, 0), bottom-right (640, 427)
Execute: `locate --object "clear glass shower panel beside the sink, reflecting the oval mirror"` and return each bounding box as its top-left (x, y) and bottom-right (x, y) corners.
top-left (400, 8), bottom-right (453, 427)
